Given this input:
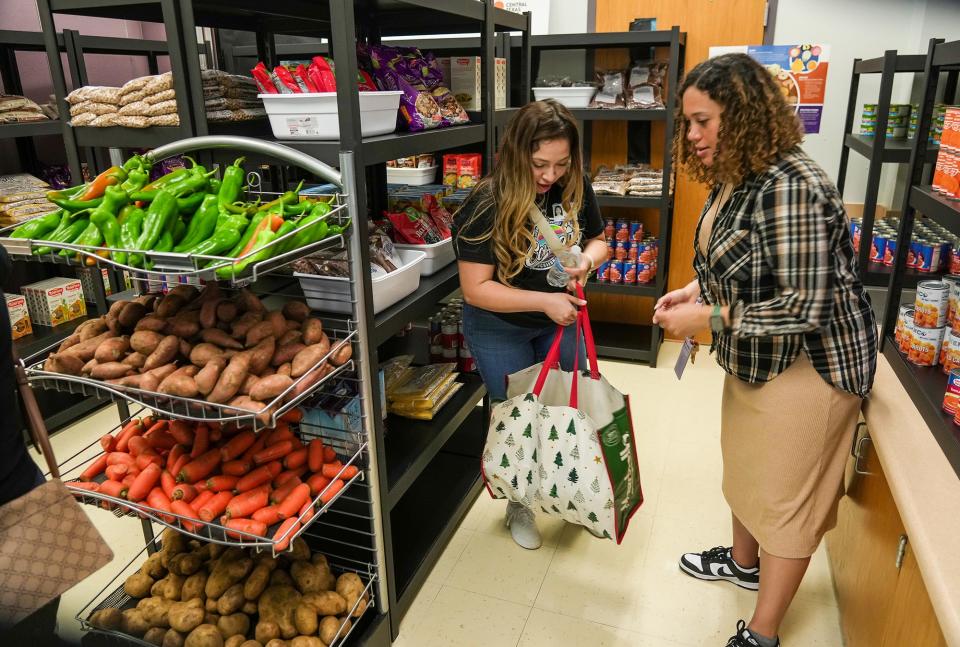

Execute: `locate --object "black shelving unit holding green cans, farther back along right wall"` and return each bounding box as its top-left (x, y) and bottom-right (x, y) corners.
top-left (837, 49), bottom-right (956, 288)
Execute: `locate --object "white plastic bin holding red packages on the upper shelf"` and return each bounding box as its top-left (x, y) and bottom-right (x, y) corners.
top-left (257, 91), bottom-right (403, 140)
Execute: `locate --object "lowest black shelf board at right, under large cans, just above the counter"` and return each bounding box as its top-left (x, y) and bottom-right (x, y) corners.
top-left (883, 337), bottom-right (960, 476)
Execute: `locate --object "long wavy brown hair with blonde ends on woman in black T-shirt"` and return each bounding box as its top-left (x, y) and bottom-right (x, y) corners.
top-left (462, 99), bottom-right (583, 285)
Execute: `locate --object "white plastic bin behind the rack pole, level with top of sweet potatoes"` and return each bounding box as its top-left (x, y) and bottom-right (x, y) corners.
top-left (293, 250), bottom-right (427, 314)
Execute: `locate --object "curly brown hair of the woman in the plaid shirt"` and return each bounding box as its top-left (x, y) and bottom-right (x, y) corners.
top-left (673, 54), bottom-right (803, 185)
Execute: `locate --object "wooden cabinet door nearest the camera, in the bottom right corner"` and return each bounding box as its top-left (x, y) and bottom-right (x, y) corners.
top-left (883, 542), bottom-right (947, 647)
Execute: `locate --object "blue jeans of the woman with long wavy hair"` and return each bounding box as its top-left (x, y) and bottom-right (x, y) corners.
top-left (463, 305), bottom-right (587, 402)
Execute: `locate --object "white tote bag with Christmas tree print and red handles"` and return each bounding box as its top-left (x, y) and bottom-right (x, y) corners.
top-left (481, 287), bottom-right (643, 544)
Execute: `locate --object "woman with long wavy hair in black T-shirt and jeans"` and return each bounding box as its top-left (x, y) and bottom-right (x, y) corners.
top-left (454, 100), bottom-right (607, 550)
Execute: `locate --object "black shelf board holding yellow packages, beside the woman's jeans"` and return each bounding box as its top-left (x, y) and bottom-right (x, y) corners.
top-left (384, 374), bottom-right (487, 508)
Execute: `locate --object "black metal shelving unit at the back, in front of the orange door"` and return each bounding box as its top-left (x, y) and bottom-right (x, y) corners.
top-left (511, 26), bottom-right (686, 367)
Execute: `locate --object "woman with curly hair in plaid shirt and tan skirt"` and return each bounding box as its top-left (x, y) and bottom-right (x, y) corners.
top-left (654, 54), bottom-right (877, 647)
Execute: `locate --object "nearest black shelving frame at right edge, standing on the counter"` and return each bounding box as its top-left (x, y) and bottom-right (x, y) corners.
top-left (877, 39), bottom-right (960, 477)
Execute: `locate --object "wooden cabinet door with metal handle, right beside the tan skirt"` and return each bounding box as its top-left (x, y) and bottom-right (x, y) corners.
top-left (827, 430), bottom-right (908, 647)
